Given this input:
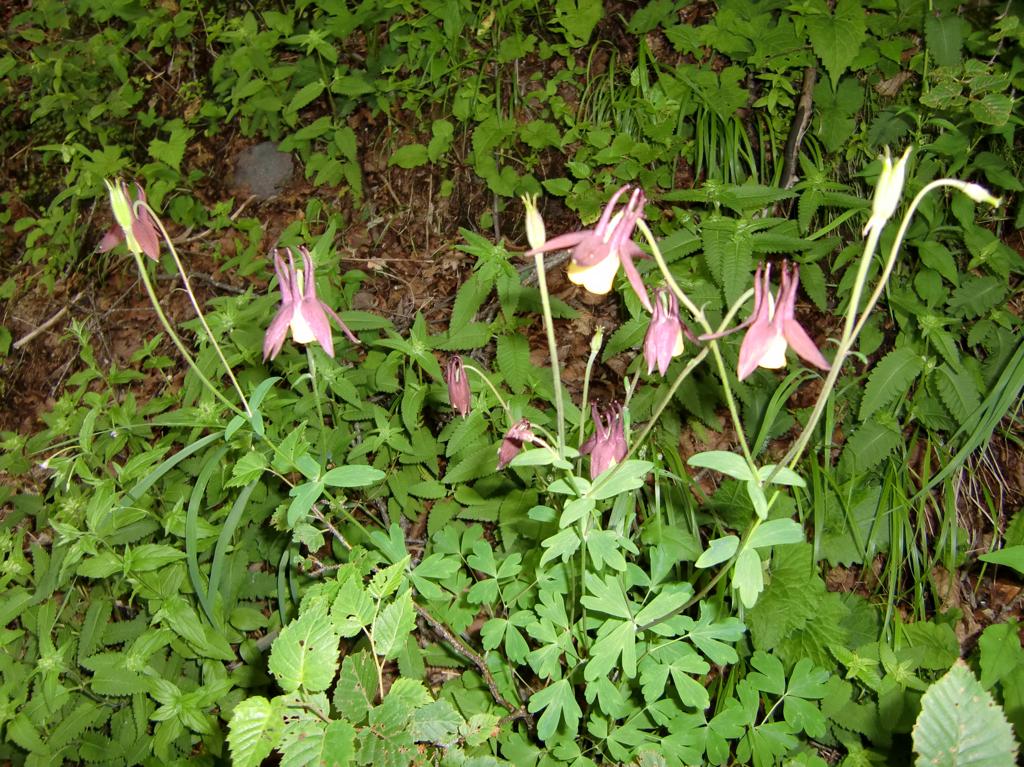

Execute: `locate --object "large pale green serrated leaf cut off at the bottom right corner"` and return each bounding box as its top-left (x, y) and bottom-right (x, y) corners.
top-left (913, 659), bottom-right (1017, 767)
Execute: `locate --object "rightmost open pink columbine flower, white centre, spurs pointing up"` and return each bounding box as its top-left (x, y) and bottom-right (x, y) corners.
top-left (736, 262), bottom-right (830, 381)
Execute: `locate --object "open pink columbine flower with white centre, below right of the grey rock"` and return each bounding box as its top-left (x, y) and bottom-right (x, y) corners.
top-left (263, 247), bottom-right (359, 359)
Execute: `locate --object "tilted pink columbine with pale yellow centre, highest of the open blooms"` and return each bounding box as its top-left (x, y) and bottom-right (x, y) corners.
top-left (527, 184), bottom-right (651, 311)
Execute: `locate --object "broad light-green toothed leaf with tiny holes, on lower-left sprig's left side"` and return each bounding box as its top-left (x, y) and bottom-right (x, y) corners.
top-left (267, 602), bottom-right (340, 692)
